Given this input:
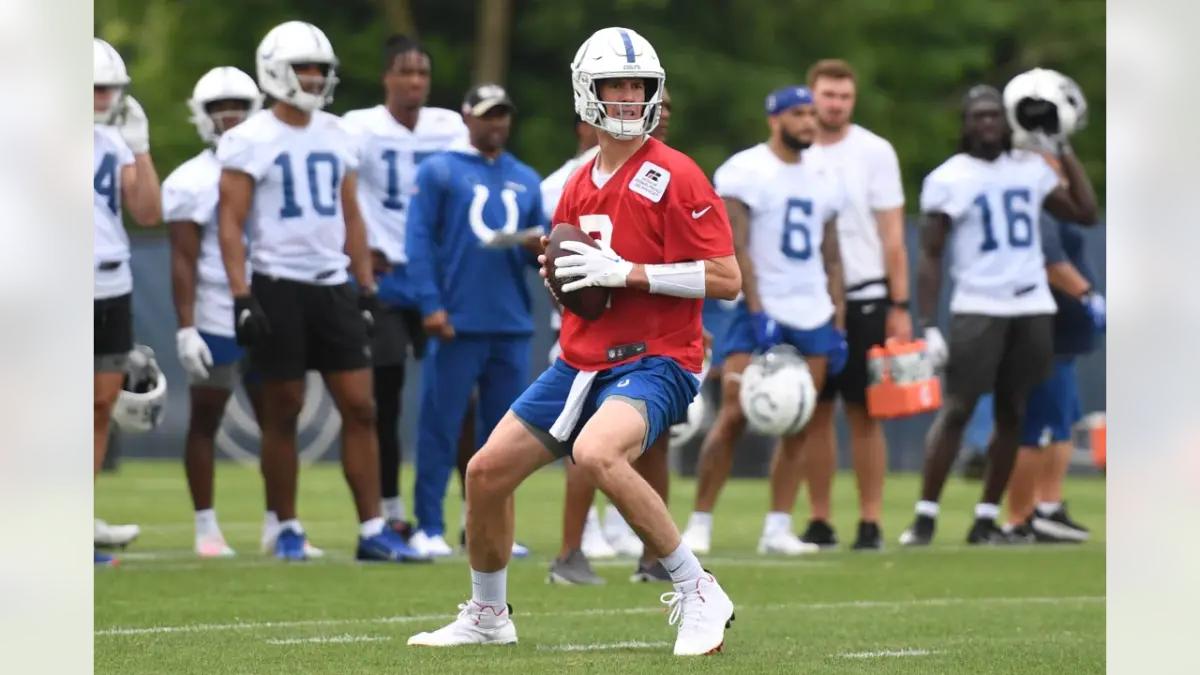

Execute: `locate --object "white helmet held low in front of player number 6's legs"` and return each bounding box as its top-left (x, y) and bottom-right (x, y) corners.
top-left (738, 345), bottom-right (817, 436)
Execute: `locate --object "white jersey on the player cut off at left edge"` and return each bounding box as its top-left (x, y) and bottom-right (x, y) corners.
top-left (91, 125), bottom-right (133, 300)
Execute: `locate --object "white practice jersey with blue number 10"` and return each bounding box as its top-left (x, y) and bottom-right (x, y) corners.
top-left (217, 110), bottom-right (359, 285)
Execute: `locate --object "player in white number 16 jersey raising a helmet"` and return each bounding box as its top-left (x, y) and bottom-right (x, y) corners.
top-left (900, 85), bottom-right (1097, 545)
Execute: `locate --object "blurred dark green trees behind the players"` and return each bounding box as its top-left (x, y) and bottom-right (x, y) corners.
top-left (95, 0), bottom-right (1105, 210)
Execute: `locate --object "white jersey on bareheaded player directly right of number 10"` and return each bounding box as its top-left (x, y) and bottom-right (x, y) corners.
top-left (342, 104), bottom-right (467, 264)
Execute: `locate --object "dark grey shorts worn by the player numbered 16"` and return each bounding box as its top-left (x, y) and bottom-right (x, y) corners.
top-left (944, 313), bottom-right (1054, 401)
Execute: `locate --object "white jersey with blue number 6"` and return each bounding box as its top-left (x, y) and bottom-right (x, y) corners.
top-left (713, 143), bottom-right (846, 330)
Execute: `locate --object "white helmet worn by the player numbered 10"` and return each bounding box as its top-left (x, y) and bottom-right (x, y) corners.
top-left (254, 22), bottom-right (337, 112)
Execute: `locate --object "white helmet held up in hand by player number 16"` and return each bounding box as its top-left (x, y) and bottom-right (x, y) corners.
top-left (1004, 68), bottom-right (1087, 148)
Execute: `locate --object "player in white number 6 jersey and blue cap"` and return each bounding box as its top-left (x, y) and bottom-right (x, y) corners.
top-left (684, 86), bottom-right (846, 555)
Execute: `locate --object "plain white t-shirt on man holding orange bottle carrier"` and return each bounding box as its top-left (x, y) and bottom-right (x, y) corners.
top-left (804, 124), bottom-right (904, 300)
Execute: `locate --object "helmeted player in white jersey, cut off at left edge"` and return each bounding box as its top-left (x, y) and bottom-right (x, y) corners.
top-left (91, 37), bottom-right (162, 565)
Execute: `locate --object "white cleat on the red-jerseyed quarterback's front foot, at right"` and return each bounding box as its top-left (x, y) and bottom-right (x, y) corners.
top-left (659, 572), bottom-right (733, 656)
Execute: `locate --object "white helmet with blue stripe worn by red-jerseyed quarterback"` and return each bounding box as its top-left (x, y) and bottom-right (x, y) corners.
top-left (571, 28), bottom-right (667, 139)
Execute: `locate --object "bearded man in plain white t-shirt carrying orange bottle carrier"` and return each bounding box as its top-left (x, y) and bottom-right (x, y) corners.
top-left (800, 59), bottom-right (912, 549)
